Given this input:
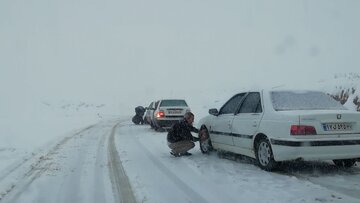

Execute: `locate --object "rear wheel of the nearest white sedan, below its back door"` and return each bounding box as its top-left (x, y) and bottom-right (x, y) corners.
top-left (255, 138), bottom-right (278, 171)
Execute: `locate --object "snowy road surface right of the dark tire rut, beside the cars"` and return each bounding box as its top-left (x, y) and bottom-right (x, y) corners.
top-left (117, 119), bottom-right (360, 203)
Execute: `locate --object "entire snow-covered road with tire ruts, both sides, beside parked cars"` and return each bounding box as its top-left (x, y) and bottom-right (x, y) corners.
top-left (0, 119), bottom-right (360, 203)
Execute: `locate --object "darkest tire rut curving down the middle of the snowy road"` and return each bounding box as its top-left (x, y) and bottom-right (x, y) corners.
top-left (108, 123), bottom-right (136, 203)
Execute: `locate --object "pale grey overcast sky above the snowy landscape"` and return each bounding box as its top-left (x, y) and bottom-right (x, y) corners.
top-left (0, 0), bottom-right (360, 108)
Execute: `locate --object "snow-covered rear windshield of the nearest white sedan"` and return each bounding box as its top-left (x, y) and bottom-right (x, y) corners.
top-left (271, 91), bottom-right (346, 111)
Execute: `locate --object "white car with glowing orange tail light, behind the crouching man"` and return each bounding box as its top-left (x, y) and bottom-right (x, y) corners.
top-left (153, 99), bottom-right (190, 130)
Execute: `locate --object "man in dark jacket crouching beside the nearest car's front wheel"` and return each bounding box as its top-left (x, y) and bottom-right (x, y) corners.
top-left (167, 112), bottom-right (199, 157)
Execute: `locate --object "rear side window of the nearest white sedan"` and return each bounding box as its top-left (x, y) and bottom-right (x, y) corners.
top-left (239, 92), bottom-right (262, 113)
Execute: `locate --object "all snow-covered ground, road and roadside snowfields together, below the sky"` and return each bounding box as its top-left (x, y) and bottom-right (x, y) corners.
top-left (0, 79), bottom-right (360, 203)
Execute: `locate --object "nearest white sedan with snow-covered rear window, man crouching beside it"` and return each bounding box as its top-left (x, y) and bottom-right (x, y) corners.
top-left (198, 90), bottom-right (360, 171)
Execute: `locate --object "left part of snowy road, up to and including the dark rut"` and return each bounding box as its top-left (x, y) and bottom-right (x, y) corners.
top-left (1, 120), bottom-right (135, 203)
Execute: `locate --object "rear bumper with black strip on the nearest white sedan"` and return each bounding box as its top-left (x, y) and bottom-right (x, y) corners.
top-left (271, 138), bottom-right (360, 161)
